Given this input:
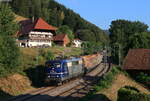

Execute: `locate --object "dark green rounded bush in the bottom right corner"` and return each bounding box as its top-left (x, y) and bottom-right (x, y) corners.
top-left (117, 87), bottom-right (150, 101)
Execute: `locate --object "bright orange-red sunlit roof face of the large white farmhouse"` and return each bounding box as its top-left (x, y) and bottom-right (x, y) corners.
top-left (34, 18), bottom-right (57, 30)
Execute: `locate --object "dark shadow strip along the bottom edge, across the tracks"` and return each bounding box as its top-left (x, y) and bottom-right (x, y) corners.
top-left (5, 94), bottom-right (111, 101)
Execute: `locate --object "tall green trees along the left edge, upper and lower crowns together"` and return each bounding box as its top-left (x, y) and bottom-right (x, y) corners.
top-left (0, 4), bottom-right (20, 76)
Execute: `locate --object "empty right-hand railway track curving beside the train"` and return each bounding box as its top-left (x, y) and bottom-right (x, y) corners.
top-left (49, 63), bottom-right (110, 101)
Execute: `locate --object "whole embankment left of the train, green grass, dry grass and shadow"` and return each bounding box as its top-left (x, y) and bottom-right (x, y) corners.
top-left (0, 46), bottom-right (82, 100)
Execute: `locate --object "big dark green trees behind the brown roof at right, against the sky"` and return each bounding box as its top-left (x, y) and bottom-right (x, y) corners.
top-left (109, 20), bottom-right (150, 65)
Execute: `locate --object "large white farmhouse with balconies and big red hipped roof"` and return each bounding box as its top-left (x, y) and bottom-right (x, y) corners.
top-left (18, 18), bottom-right (57, 47)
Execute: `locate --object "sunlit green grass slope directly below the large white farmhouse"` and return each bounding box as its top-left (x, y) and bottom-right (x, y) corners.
top-left (20, 46), bottom-right (82, 70)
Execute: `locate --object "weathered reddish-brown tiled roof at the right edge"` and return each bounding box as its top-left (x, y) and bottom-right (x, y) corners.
top-left (123, 49), bottom-right (150, 70)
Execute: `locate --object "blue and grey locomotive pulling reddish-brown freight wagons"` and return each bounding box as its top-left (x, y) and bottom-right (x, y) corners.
top-left (45, 54), bottom-right (102, 85)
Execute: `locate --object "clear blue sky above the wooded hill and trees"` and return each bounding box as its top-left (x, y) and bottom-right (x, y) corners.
top-left (56, 0), bottom-right (150, 29)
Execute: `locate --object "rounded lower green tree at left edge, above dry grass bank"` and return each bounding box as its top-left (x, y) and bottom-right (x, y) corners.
top-left (0, 35), bottom-right (20, 76)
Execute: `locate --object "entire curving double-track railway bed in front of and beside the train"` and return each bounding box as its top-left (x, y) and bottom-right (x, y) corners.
top-left (8, 64), bottom-right (109, 101)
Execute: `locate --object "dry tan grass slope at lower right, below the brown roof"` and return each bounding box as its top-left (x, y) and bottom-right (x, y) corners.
top-left (98, 73), bottom-right (150, 101)
